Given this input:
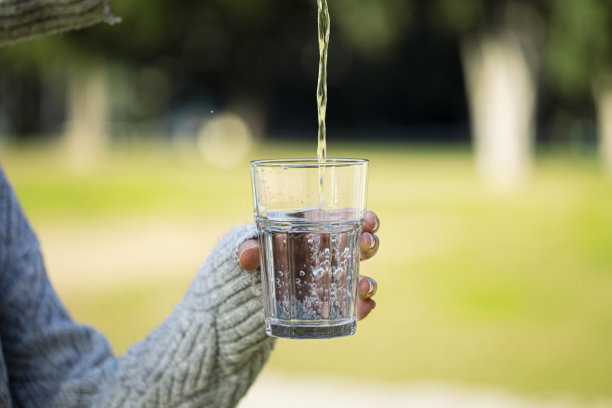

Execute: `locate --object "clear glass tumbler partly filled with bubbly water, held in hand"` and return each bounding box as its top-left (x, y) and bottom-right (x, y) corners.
top-left (251, 159), bottom-right (368, 339)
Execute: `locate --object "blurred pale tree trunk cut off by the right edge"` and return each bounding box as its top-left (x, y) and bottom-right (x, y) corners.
top-left (593, 72), bottom-right (612, 177)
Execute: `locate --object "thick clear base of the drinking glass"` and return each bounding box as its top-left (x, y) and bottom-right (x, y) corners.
top-left (266, 319), bottom-right (357, 339)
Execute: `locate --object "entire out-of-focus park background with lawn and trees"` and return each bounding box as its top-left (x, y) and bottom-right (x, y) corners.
top-left (0, 0), bottom-right (612, 408)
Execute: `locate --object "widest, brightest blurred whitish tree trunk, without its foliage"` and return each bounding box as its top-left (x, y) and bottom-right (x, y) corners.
top-left (462, 31), bottom-right (536, 191)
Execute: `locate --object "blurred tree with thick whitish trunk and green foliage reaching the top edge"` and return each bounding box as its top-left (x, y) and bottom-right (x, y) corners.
top-left (433, 0), bottom-right (543, 190)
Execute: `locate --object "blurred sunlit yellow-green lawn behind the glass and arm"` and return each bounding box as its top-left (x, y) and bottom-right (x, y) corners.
top-left (0, 143), bottom-right (612, 399)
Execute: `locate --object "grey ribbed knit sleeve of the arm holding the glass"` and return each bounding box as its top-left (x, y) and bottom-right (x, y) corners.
top-left (0, 164), bottom-right (273, 408)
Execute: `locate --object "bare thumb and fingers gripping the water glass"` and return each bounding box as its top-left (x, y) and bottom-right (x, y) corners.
top-left (238, 211), bottom-right (380, 320)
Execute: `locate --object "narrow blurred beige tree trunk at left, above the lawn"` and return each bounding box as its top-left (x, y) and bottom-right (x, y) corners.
top-left (64, 63), bottom-right (108, 169)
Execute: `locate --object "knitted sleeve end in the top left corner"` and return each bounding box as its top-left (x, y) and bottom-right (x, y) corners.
top-left (0, 0), bottom-right (120, 46)
